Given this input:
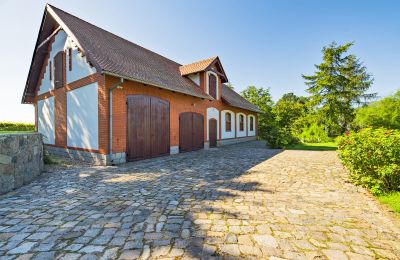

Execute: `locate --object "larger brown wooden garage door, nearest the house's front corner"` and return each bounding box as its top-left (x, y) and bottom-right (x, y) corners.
top-left (126, 95), bottom-right (170, 161)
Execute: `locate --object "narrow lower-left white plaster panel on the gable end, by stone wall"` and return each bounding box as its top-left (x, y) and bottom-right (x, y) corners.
top-left (37, 97), bottom-right (55, 144)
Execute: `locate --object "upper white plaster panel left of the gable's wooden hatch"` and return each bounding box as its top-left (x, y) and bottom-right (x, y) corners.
top-left (38, 30), bottom-right (67, 95)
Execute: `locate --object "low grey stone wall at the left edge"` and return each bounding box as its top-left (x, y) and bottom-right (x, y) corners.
top-left (0, 133), bottom-right (43, 194)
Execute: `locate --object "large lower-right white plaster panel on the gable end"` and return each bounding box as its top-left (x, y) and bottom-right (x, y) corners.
top-left (67, 83), bottom-right (99, 150)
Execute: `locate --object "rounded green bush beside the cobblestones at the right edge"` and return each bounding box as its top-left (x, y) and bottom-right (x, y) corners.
top-left (338, 128), bottom-right (400, 195)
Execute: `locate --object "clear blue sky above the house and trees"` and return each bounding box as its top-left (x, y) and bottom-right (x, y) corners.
top-left (0, 0), bottom-right (400, 122)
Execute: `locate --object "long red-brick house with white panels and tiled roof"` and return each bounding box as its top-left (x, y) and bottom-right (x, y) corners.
top-left (22, 5), bottom-right (260, 164)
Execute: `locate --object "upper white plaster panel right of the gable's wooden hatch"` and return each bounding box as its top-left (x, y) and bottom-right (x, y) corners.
top-left (66, 38), bottom-right (96, 84)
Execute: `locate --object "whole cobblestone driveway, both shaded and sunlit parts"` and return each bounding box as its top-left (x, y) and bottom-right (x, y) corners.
top-left (0, 142), bottom-right (400, 259)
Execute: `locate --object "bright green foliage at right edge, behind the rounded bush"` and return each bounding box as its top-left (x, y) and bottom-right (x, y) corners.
top-left (354, 89), bottom-right (400, 129)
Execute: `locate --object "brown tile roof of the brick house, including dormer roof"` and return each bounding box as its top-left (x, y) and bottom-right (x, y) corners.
top-left (22, 5), bottom-right (257, 111)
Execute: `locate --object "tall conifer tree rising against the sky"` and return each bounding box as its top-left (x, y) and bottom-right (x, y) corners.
top-left (302, 42), bottom-right (376, 136)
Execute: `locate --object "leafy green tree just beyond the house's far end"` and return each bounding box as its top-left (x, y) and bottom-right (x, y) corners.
top-left (242, 86), bottom-right (274, 139)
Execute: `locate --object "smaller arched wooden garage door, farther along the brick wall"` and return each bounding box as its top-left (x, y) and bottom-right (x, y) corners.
top-left (179, 112), bottom-right (204, 152)
